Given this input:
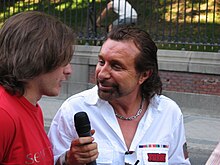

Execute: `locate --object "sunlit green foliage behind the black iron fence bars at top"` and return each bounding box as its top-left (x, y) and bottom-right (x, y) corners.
top-left (0, 0), bottom-right (220, 51)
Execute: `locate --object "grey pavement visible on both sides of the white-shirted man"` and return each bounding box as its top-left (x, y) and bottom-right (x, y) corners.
top-left (39, 98), bottom-right (220, 165)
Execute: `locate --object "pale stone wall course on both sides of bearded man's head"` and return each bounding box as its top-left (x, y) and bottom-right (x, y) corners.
top-left (71, 45), bottom-right (220, 75)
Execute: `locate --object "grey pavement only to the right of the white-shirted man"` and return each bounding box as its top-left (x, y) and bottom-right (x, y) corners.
top-left (184, 114), bottom-right (220, 165)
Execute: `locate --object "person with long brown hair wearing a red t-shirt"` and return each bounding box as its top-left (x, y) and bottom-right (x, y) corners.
top-left (0, 11), bottom-right (75, 165)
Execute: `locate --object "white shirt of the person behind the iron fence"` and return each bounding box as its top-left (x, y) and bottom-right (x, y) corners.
top-left (111, 0), bottom-right (137, 20)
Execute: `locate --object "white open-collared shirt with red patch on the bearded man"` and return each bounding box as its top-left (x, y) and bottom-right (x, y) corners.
top-left (48, 86), bottom-right (190, 165)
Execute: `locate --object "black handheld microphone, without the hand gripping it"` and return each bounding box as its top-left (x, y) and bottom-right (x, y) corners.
top-left (74, 112), bottom-right (96, 165)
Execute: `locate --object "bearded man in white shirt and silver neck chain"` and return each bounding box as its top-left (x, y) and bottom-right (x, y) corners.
top-left (49, 26), bottom-right (190, 165)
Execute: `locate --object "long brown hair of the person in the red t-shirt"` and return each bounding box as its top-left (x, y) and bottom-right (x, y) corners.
top-left (0, 11), bottom-right (75, 95)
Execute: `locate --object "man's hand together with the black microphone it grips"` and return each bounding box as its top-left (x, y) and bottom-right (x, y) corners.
top-left (59, 112), bottom-right (98, 165)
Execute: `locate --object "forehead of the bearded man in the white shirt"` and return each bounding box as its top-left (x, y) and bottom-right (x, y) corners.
top-left (100, 39), bottom-right (140, 59)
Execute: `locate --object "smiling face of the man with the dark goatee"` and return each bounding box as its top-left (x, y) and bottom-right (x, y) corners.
top-left (96, 39), bottom-right (142, 101)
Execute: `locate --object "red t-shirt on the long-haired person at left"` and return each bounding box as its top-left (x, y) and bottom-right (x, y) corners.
top-left (0, 86), bottom-right (54, 165)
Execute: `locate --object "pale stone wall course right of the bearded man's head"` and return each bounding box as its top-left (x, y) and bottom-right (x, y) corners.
top-left (158, 50), bottom-right (220, 75)
